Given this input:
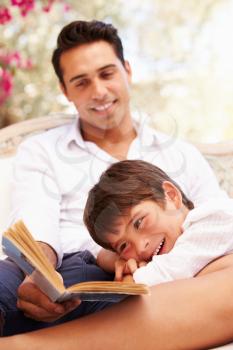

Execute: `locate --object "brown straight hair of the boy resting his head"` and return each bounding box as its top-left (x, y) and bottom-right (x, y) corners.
top-left (83, 160), bottom-right (194, 249)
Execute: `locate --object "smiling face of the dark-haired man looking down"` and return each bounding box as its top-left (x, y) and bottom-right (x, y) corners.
top-left (60, 41), bottom-right (131, 130)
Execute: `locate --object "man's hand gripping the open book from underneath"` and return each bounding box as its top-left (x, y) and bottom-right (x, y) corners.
top-left (17, 276), bottom-right (81, 322)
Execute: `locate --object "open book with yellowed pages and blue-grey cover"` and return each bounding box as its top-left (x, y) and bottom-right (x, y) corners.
top-left (2, 221), bottom-right (149, 302)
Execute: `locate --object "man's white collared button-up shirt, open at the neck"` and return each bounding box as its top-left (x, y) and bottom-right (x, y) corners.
top-left (9, 113), bottom-right (225, 266)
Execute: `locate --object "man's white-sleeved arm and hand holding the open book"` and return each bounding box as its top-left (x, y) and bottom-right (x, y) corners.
top-left (10, 137), bottom-right (81, 321)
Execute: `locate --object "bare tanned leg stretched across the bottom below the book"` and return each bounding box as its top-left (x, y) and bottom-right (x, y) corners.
top-left (3, 255), bottom-right (233, 350)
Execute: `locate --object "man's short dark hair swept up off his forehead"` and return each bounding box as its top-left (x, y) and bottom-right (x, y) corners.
top-left (52, 21), bottom-right (125, 86)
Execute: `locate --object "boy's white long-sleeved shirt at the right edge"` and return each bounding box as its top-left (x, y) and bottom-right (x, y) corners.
top-left (133, 199), bottom-right (233, 286)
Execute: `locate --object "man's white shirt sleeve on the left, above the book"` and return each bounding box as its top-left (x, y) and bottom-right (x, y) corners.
top-left (9, 137), bottom-right (63, 267)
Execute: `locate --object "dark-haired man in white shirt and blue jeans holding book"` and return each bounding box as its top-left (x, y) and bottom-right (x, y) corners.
top-left (0, 21), bottom-right (228, 335)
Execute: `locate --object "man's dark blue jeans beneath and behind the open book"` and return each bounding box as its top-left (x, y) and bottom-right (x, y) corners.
top-left (0, 251), bottom-right (116, 336)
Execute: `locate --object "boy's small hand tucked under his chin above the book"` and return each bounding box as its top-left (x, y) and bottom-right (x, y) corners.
top-left (115, 258), bottom-right (146, 281)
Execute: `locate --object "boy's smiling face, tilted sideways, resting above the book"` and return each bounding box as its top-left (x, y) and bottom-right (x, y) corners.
top-left (106, 185), bottom-right (188, 261)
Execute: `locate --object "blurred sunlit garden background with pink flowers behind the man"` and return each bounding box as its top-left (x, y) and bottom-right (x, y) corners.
top-left (0, 0), bottom-right (233, 142)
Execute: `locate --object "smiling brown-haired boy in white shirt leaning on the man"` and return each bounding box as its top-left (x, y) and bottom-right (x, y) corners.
top-left (84, 160), bottom-right (233, 285)
